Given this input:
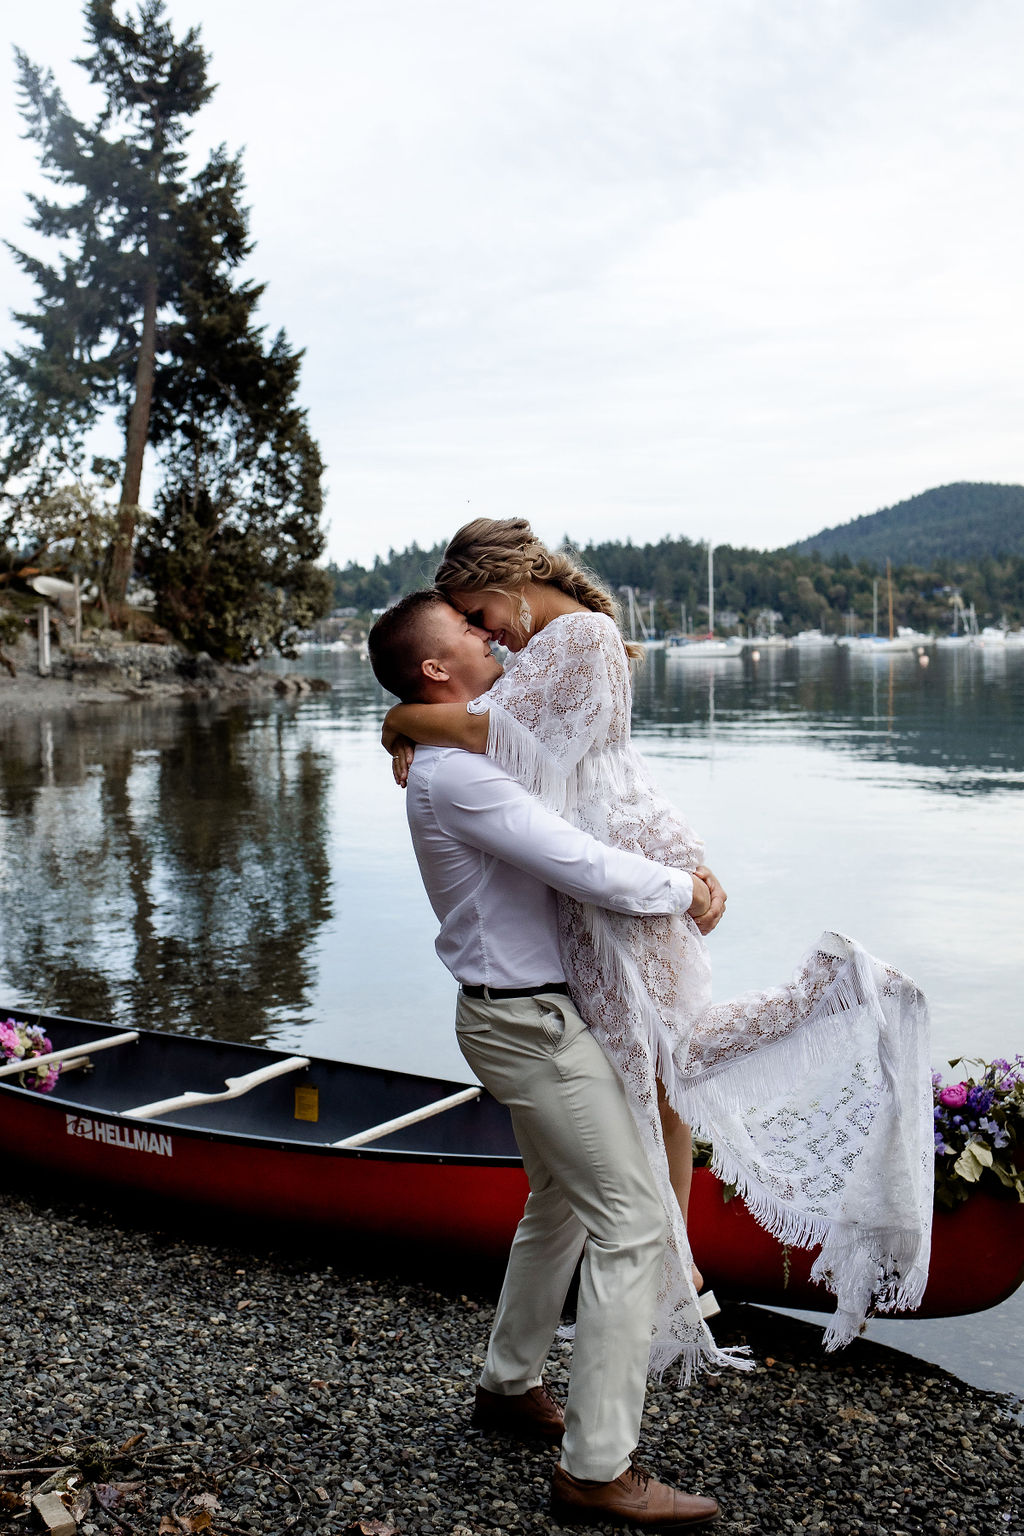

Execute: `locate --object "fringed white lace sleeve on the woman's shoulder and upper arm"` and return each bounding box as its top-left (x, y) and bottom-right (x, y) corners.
top-left (468, 613), bottom-right (629, 811)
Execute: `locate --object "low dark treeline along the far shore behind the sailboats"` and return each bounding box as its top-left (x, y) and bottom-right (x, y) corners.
top-left (330, 522), bottom-right (1024, 634)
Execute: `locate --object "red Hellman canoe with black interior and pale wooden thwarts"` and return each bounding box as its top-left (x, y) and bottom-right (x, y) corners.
top-left (0, 1009), bottom-right (1024, 1318)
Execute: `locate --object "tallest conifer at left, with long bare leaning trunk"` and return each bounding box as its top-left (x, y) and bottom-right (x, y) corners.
top-left (5, 0), bottom-right (213, 604)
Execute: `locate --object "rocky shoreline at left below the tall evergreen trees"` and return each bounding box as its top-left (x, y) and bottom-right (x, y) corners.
top-left (0, 631), bottom-right (329, 719)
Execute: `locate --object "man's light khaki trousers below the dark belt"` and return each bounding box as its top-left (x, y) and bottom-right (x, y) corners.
top-left (456, 992), bottom-right (668, 1482)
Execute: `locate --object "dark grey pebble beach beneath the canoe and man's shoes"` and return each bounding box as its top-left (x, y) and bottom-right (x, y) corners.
top-left (0, 1193), bottom-right (1024, 1536)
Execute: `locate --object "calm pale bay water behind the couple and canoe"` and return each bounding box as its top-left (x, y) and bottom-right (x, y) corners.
top-left (0, 650), bottom-right (1024, 1395)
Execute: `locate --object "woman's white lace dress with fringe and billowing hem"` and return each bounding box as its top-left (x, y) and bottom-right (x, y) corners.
top-left (468, 613), bottom-right (933, 1381)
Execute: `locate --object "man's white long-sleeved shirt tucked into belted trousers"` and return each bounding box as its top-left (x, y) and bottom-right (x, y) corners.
top-left (405, 746), bottom-right (694, 988)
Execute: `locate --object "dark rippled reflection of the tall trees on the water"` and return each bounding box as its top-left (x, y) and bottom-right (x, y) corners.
top-left (0, 708), bottom-right (332, 1040)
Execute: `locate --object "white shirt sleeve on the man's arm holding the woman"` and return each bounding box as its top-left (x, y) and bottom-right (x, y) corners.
top-left (430, 751), bottom-right (694, 915)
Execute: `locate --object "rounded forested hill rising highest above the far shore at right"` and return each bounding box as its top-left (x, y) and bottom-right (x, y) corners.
top-left (791, 481), bottom-right (1024, 567)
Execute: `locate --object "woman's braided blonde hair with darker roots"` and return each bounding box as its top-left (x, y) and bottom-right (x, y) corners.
top-left (434, 518), bottom-right (643, 659)
